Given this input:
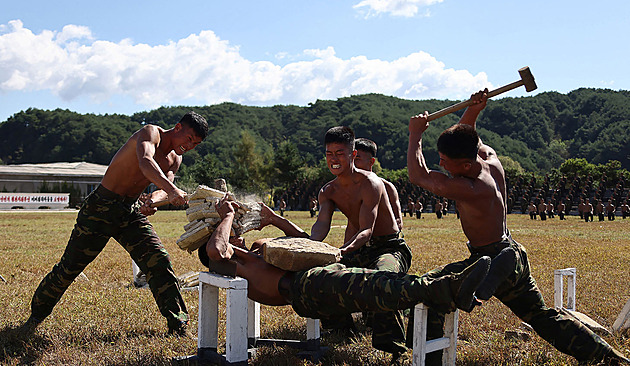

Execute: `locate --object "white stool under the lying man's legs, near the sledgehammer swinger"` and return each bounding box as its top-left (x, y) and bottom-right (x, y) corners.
top-left (413, 303), bottom-right (459, 366)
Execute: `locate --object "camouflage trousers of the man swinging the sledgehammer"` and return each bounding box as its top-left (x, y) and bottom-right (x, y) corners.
top-left (422, 237), bottom-right (612, 365)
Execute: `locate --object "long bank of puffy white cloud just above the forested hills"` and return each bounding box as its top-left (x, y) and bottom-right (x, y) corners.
top-left (0, 20), bottom-right (490, 108)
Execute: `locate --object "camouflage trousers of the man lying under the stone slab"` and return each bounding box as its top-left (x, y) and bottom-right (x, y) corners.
top-left (286, 263), bottom-right (460, 326)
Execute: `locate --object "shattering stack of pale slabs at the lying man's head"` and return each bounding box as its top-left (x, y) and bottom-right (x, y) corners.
top-left (177, 185), bottom-right (261, 252)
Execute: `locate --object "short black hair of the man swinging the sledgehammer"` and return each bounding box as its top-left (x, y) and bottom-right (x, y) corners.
top-left (437, 123), bottom-right (479, 160)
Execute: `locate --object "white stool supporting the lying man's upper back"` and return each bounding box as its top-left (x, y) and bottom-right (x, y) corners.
top-left (197, 272), bottom-right (321, 365)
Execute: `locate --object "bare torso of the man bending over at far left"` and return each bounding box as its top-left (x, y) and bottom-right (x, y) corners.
top-left (101, 126), bottom-right (180, 197)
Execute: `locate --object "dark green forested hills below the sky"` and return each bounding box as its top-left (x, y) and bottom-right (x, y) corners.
top-left (0, 89), bottom-right (630, 172)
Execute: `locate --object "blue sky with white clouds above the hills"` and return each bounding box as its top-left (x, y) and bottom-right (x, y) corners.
top-left (0, 0), bottom-right (630, 122)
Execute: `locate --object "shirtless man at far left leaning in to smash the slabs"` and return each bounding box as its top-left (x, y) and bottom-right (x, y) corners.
top-left (27, 112), bottom-right (208, 335)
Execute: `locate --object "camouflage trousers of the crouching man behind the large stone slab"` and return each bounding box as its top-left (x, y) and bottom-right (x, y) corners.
top-left (322, 235), bottom-right (411, 353)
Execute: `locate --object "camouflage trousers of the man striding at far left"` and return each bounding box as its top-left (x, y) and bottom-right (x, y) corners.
top-left (31, 186), bottom-right (188, 329)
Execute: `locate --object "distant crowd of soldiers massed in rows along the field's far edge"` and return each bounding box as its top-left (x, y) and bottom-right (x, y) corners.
top-left (273, 174), bottom-right (630, 222)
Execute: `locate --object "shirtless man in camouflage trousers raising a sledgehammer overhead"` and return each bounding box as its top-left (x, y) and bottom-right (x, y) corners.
top-left (407, 89), bottom-right (630, 364)
